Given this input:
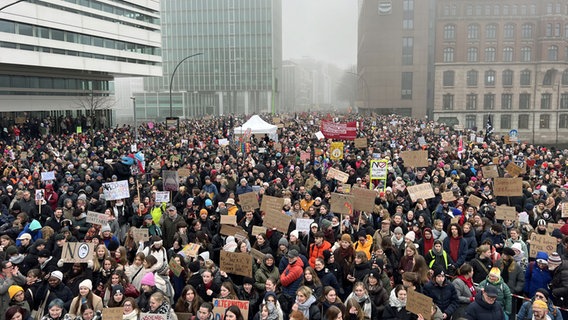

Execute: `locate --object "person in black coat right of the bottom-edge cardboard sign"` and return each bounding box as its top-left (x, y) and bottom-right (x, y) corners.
top-left (423, 269), bottom-right (459, 319)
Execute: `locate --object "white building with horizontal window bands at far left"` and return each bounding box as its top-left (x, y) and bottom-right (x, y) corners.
top-left (0, 0), bottom-right (162, 129)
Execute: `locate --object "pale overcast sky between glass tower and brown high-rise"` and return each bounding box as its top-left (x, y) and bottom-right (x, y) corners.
top-left (282, 0), bottom-right (357, 67)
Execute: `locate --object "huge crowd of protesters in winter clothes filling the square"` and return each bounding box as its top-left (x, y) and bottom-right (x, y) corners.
top-left (0, 113), bottom-right (568, 320)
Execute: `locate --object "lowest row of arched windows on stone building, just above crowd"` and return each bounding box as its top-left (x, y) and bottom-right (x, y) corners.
top-left (465, 114), bottom-right (568, 130)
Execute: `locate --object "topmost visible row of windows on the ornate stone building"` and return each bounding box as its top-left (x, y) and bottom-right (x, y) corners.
top-left (442, 2), bottom-right (568, 17)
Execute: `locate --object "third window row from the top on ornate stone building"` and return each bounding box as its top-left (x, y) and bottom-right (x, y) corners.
top-left (442, 45), bottom-right (568, 63)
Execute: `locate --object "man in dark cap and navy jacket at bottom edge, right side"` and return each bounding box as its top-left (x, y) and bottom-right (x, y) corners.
top-left (465, 286), bottom-right (505, 320)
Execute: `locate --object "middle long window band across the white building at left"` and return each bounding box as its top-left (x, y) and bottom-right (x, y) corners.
top-left (0, 20), bottom-right (160, 55)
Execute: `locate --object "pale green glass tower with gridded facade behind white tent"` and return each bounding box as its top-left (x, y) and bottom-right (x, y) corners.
top-left (133, 0), bottom-right (282, 120)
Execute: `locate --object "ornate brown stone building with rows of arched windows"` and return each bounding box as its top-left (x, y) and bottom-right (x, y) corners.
top-left (434, 0), bottom-right (568, 143)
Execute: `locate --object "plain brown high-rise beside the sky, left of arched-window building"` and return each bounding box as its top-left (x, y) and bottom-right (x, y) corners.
top-left (357, 0), bottom-right (435, 118)
